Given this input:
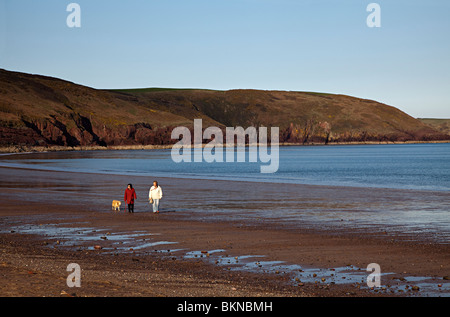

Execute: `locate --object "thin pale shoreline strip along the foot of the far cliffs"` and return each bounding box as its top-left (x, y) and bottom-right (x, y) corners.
top-left (0, 140), bottom-right (450, 154)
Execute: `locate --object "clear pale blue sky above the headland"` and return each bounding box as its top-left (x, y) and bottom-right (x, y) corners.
top-left (0, 0), bottom-right (450, 118)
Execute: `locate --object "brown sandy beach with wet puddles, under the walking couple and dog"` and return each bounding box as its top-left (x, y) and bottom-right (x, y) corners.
top-left (0, 168), bottom-right (450, 297)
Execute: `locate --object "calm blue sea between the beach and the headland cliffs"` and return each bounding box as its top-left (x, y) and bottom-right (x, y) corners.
top-left (0, 143), bottom-right (450, 191)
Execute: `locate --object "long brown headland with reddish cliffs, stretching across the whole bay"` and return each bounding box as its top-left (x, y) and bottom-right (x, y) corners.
top-left (0, 70), bottom-right (450, 146)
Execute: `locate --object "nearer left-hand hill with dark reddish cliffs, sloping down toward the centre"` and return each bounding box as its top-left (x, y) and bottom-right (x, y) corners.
top-left (0, 70), bottom-right (190, 146)
